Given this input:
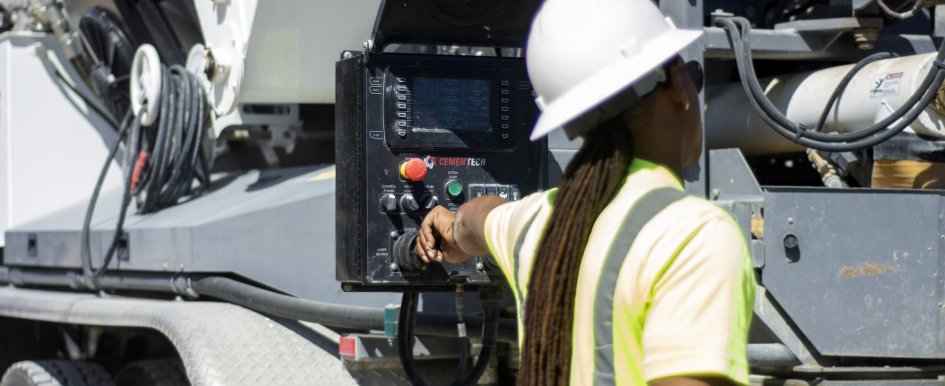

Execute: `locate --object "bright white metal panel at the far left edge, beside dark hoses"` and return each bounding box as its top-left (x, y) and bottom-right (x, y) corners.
top-left (0, 33), bottom-right (121, 245)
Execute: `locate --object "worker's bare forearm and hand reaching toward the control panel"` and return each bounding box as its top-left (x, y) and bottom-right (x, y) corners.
top-left (417, 195), bottom-right (506, 263)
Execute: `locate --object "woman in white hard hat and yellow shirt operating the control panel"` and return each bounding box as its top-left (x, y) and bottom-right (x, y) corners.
top-left (417, 0), bottom-right (755, 386)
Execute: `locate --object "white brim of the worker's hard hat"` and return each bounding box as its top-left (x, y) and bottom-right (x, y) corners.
top-left (530, 29), bottom-right (702, 141)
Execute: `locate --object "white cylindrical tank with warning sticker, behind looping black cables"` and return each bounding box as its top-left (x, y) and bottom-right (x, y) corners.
top-left (705, 54), bottom-right (945, 155)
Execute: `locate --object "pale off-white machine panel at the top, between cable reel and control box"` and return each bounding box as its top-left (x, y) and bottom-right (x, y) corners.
top-left (194, 0), bottom-right (380, 105)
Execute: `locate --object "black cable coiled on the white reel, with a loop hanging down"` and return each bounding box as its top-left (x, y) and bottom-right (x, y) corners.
top-left (80, 60), bottom-right (210, 289)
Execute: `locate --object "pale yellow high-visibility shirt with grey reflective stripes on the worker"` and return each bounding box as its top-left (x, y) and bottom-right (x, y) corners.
top-left (485, 159), bottom-right (755, 386)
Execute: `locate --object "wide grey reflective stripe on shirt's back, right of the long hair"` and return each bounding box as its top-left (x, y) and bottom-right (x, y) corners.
top-left (594, 188), bottom-right (687, 386)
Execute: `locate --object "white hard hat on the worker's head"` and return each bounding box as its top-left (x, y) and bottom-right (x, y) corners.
top-left (526, 0), bottom-right (702, 140)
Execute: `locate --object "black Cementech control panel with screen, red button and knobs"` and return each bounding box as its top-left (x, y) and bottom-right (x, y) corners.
top-left (336, 54), bottom-right (547, 291)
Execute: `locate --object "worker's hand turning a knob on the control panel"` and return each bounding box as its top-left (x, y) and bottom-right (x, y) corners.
top-left (417, 206), bottom-right (471, 264)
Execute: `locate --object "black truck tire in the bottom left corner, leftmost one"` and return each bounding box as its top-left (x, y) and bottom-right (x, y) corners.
top-left (0, 359), bottom-right (115, 386)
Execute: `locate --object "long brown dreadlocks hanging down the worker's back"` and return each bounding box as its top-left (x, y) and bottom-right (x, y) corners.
top-left (517, 89), bottom-right (655, 386)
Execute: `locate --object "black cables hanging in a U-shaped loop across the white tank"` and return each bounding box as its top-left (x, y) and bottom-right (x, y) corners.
top-left (715, 17), bottom-right (945, 152)
